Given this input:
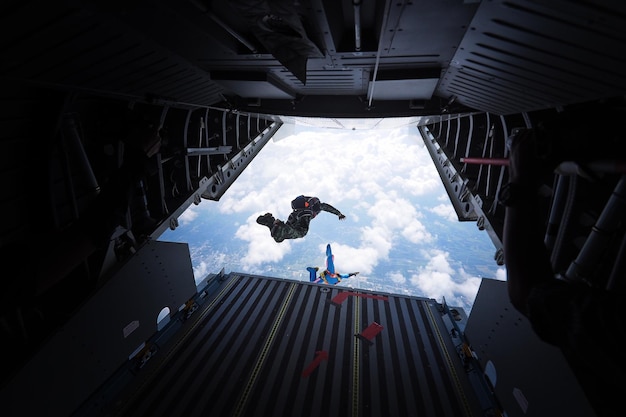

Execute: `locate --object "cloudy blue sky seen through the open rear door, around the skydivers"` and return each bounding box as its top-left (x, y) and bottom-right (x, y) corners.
top-left (160, 122), bottom-right (505, 314)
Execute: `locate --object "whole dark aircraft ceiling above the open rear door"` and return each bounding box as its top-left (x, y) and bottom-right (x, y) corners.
top-left (0, 0), bottom-right (626, 117)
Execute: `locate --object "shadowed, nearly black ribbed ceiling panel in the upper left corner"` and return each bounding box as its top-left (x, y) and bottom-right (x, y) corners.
top-left (0, 2), bottom-right (221, 105)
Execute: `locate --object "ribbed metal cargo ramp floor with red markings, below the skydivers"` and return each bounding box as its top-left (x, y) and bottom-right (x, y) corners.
top-left (111, 273), bottom-right (482, 417)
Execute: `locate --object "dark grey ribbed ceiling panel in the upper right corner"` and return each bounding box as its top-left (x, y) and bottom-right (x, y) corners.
top-left (437, 0), bottom-right (626, 115)
